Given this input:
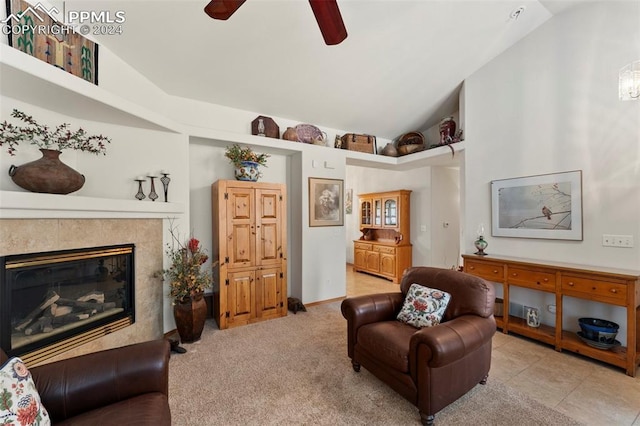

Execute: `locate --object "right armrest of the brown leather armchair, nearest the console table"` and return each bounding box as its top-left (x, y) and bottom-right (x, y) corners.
top-left (409, 315), bottom-right (496, 375)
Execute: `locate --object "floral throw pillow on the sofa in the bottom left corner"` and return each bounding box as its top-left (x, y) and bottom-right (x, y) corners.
top-left (0, 358), bottom-right (51, 426)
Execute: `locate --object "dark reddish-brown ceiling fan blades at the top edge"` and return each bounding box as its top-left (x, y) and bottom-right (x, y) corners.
top-left (204, 0), bottom-right (347, 45)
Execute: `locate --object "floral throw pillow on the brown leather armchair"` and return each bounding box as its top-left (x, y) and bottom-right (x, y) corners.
top-left (397, 284), bottom-right (451, 328)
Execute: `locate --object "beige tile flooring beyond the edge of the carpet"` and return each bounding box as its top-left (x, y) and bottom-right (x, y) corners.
top-left (347, 265), bottom-right (640, 426)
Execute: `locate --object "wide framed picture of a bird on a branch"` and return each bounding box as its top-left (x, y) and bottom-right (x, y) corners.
top-left (491, 170), bottom-right (582, 241)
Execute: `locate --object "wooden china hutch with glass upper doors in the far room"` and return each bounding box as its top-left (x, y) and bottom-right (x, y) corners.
top-left (353, 189), bottom-right (412, 284)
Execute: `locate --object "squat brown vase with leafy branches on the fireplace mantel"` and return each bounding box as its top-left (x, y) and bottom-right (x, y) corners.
top-left (0, 109), bottom-right (111, 194)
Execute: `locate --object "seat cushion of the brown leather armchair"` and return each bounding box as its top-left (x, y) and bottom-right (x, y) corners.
top-left (357, 321), bottom-right (416, 373)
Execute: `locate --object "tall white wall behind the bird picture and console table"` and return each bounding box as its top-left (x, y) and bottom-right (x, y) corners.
top-left (463, 1), bottom-right (640, 336)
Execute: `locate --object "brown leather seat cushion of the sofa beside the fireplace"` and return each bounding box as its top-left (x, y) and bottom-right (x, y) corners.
top-left (56, 392), bottom-right (171, 426)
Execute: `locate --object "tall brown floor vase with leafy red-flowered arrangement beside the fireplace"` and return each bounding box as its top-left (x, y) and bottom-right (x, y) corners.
top-left (162, 221), bottom-right (212, 343)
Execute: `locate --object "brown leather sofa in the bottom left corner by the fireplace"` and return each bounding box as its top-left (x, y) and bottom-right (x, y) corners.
top-left (0, 340), bottom-right (171, 426)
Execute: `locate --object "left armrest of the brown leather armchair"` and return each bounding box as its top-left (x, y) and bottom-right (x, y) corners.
top-left (340, 292), bottom-right (404, 359)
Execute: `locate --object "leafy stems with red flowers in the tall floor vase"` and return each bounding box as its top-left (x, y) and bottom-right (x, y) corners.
top-left (159, 221), bottom-right (212, 302)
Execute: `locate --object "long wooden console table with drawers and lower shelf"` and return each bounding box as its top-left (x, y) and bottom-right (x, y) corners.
top-left (462, 254), bottom-right (640, 377)
